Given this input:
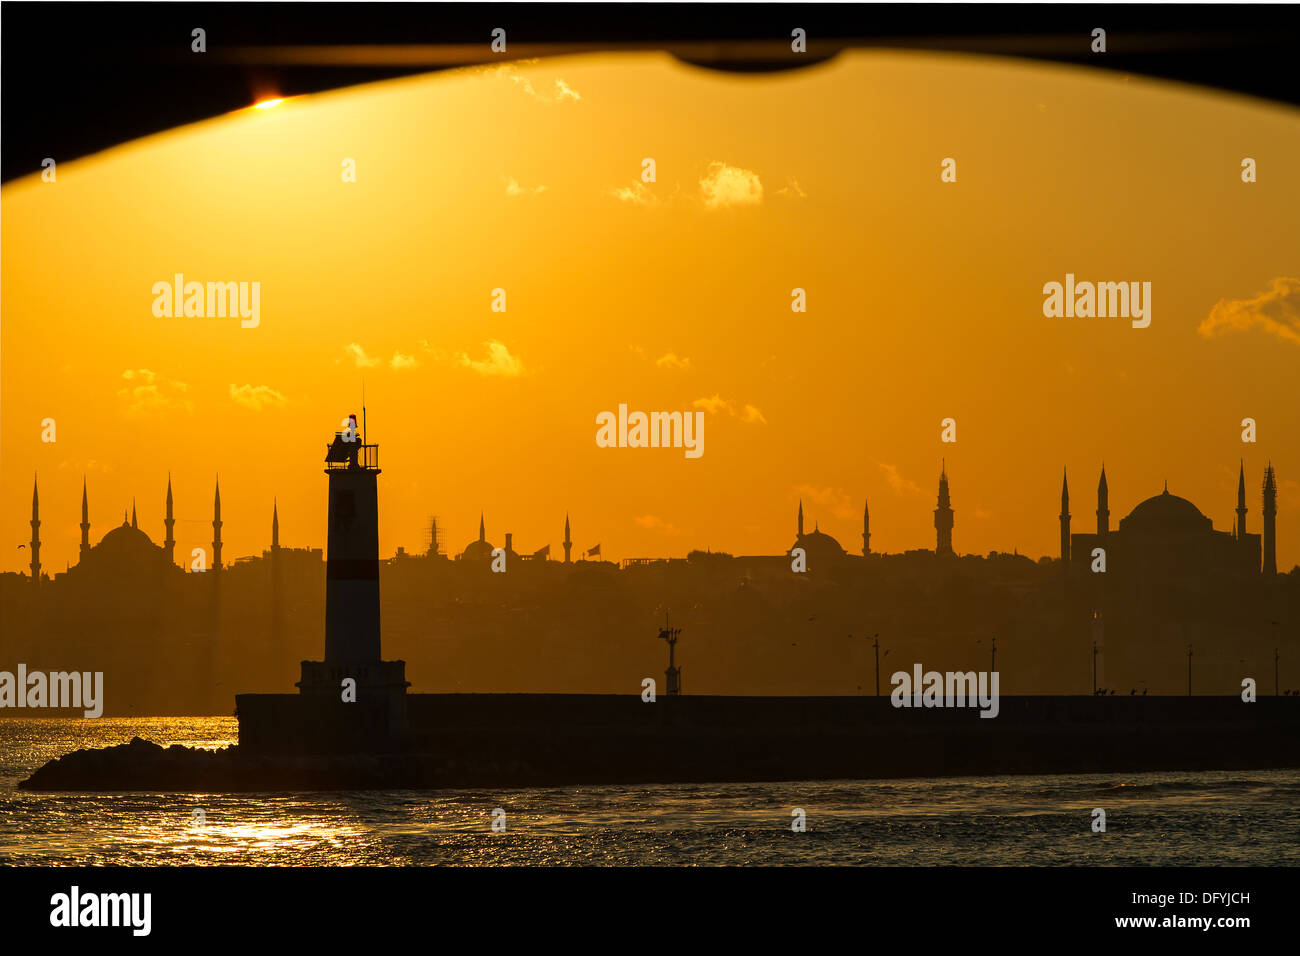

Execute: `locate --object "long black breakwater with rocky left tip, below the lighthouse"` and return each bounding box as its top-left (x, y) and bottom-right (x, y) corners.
top-left (18, 695), bottom-right (1300, 792)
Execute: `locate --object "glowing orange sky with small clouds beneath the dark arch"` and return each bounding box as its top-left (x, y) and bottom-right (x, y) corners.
top-left (0, 53), bottom-right (1300, 571)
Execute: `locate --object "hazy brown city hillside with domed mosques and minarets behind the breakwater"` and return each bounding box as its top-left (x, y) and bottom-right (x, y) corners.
top-left (0, 462), bottom-right (1300, 714)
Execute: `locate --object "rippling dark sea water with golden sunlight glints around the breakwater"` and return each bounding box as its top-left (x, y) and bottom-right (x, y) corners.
top-left (0, 718), bottom-right (1300, 866)
